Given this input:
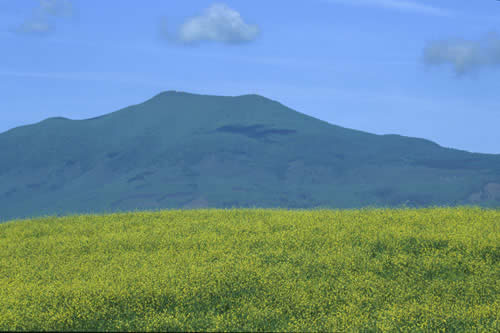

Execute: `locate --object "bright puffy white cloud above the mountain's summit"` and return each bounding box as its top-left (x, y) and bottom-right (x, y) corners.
top-left (162, 4), bottom-right (259, 44)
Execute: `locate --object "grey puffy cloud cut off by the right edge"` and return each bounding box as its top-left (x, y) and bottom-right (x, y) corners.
top-left (423, 32), bottom-right (500, 76)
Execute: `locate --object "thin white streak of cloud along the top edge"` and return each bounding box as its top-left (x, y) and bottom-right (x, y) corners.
top-left (323, 0), bottom-right (451, 16)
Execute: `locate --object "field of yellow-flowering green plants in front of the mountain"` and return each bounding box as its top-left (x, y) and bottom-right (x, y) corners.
top-left (0, 207), bottom-right (500, 331)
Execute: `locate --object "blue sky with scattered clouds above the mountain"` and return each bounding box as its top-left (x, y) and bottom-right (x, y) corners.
top-left (0, 0), bottom-right (500, 154)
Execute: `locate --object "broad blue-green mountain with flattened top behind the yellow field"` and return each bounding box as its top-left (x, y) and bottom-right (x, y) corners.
top-left (0, 91), bottom-right (500, 221)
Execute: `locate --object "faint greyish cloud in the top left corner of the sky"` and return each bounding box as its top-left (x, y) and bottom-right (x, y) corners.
top-left (11, 0), bottom-right (74, 35)
